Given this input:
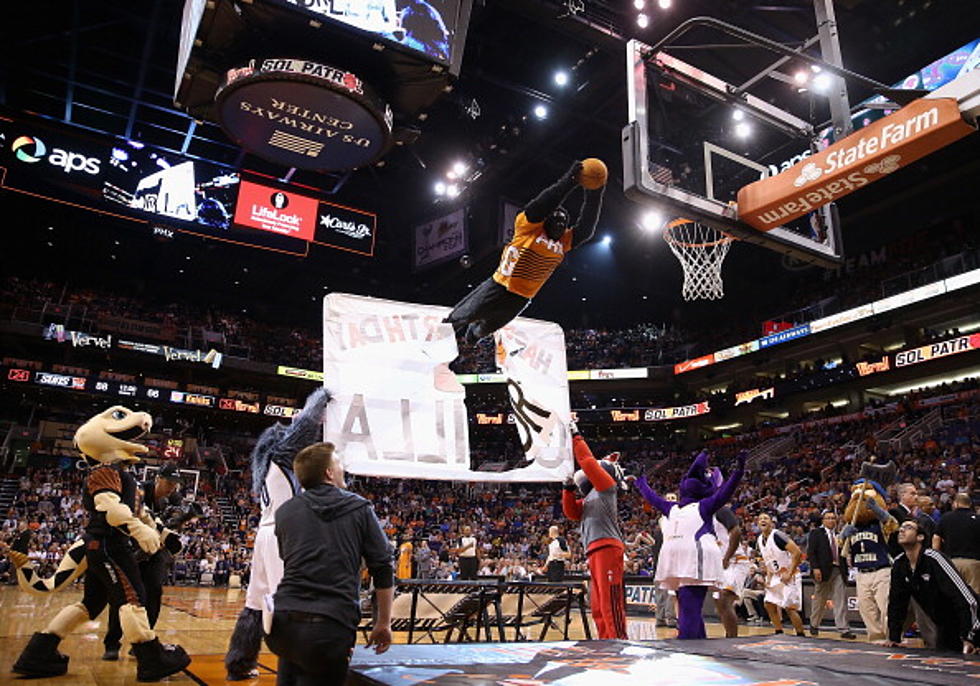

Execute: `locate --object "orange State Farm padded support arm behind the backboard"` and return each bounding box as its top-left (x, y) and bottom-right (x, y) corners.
top-left (738, 90), bottom-right (980, 231)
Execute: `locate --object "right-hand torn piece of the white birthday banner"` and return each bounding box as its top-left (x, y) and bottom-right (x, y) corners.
top-left (494, 317), bottom-right (574, 481)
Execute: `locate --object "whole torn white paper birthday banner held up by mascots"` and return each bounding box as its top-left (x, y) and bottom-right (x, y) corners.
top-left (323, 293), bottom-right (572, 481)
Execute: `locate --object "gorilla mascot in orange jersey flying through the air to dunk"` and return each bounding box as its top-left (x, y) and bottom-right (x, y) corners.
top-left (444, 162), bottom-right (605, 343)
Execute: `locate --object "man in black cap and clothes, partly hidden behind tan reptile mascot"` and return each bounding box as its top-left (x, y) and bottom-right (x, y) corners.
top-left (102, 464), bottom-right (186, 661)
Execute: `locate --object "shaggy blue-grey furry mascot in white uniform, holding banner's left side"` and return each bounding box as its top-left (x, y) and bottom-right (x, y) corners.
top-left (225, 388), bottom-right (331, 681)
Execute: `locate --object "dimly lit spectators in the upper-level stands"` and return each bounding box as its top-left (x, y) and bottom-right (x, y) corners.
top-left (0, 222), bottom-right (980, 373)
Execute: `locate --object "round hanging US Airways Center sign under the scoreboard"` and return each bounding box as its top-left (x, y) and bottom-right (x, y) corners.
top-left (215, 58), bottom-right (392, 171)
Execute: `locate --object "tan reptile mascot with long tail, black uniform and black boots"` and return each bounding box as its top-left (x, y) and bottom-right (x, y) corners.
top-left (8, 405), bottom-right (190, 681)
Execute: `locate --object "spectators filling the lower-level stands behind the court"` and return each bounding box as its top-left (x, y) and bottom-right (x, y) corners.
top-left (0, 379), bottom-right (980, 600)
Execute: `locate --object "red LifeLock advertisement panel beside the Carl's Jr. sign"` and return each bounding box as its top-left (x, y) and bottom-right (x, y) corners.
top-left (235, 181), bottom-right (317, 241)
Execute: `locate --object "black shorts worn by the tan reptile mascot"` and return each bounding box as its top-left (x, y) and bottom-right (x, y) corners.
top-left (82, 538), bottom-right (146, 619)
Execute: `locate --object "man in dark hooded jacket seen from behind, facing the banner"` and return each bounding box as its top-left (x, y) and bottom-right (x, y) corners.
top-left (266, 443), bottom-right (394, 686)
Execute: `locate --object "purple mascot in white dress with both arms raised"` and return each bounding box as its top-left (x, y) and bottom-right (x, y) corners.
top-left (636, 451), bottom-right (747, 639)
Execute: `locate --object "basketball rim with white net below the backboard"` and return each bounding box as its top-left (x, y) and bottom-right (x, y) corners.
top-left (664, 218), bottom-right (735, 300)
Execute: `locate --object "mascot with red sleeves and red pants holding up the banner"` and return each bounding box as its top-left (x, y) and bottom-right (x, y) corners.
top-left (561, 422), bottom-right (626, 639)
